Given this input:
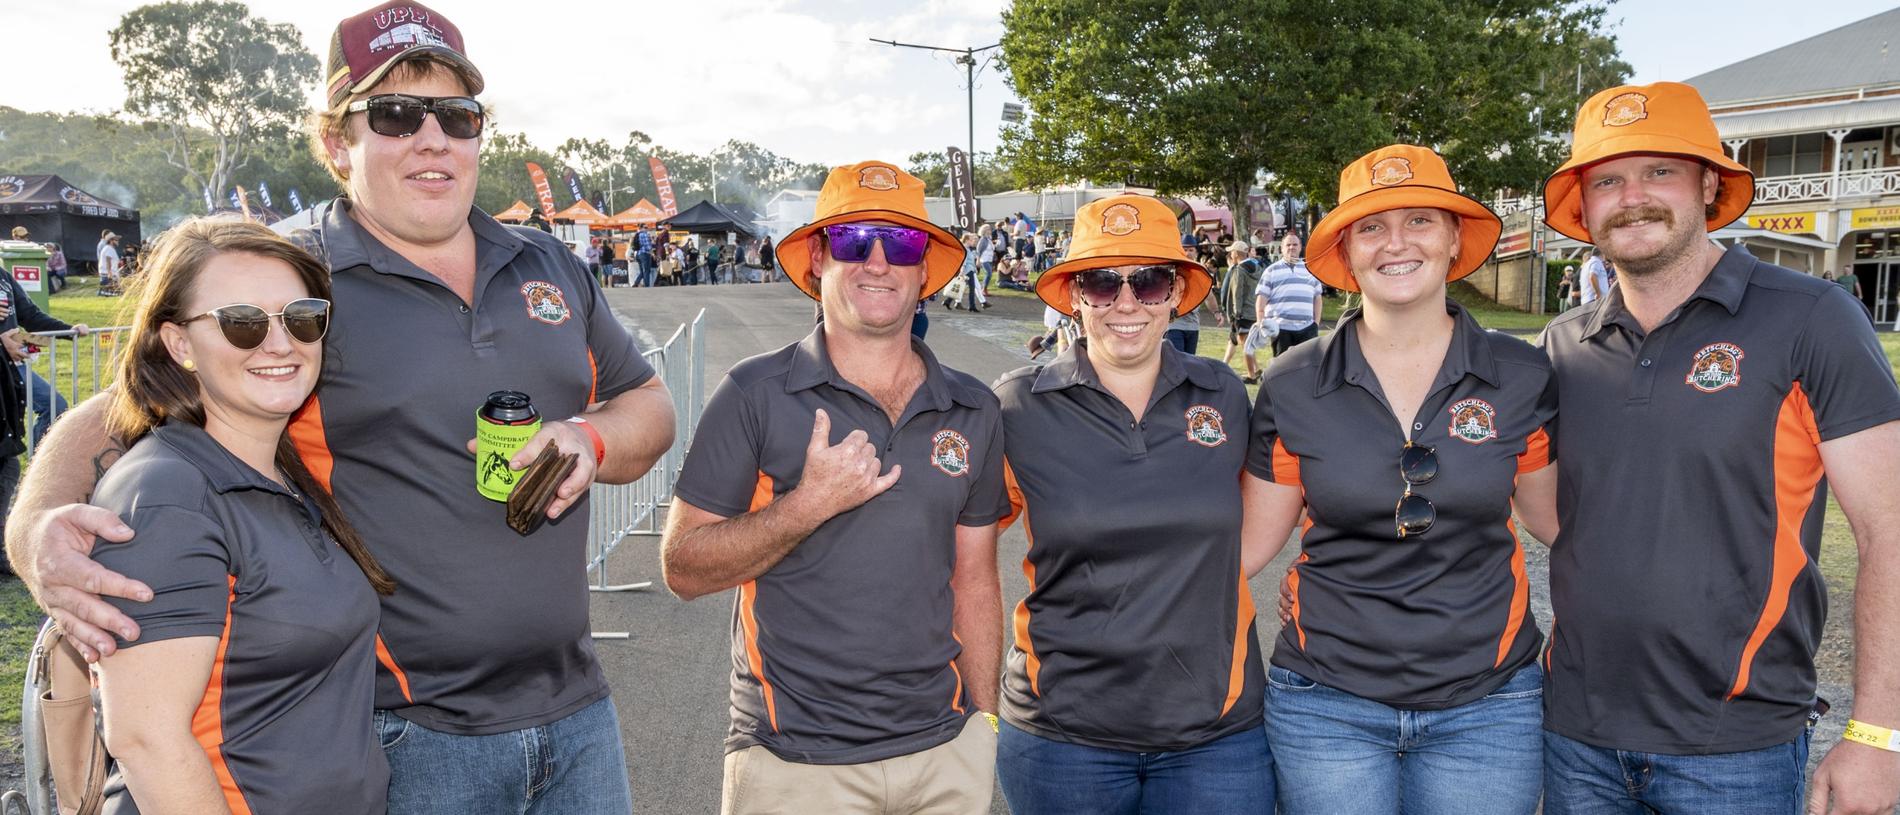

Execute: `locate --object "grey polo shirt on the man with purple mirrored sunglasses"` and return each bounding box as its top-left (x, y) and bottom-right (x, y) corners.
top-left (675, 325), bottom-right (1009, 764)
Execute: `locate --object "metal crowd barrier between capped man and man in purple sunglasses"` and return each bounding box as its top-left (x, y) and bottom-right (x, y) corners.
top-left (587, 303), bottom-right (707, 591)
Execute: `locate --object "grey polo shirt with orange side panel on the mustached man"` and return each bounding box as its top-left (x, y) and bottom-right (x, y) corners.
top-left (1543, 249), bottom-right (1900, 754)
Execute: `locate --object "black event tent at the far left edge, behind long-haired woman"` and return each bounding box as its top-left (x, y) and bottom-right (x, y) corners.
top-left (0, 175), bottom-right (141, 265)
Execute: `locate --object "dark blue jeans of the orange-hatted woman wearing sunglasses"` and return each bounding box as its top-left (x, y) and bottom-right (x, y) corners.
top-left (996, 722), bottom-right (1273, 815)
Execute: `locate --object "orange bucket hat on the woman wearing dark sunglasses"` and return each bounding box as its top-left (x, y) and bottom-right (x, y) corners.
top-left (1036, 192), bottom-right (1214, 317)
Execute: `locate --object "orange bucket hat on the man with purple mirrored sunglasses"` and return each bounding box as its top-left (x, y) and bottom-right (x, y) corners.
top-left (775, 161), bottom-right (963, 300)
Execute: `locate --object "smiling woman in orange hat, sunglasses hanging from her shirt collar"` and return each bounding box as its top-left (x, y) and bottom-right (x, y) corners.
top-left (1243, 144), bottom-right (1556, 815)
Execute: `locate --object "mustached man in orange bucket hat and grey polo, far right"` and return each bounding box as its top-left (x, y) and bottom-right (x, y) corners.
top-left (1543, 82), bottom-right (1900, 815)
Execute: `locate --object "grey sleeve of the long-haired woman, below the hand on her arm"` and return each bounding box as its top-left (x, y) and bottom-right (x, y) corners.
top-left (93, 505), bottom-right (234, 648)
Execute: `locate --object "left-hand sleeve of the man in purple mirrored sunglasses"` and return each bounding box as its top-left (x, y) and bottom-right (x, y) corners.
top-left (673, 376), bottom-right (756, 519)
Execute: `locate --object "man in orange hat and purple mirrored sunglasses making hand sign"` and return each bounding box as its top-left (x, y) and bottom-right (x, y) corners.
top-left (661, 161), bottom-right (1009, 815)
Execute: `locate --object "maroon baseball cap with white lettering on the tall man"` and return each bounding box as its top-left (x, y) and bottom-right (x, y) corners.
top-left (327, 2), bottom-right (483, 106)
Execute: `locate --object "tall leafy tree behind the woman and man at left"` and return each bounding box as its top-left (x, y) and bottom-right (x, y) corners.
top-left (110, 0), bottom-right (317, 215)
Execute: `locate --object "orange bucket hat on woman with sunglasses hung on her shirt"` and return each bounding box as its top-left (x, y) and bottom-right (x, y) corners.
top-left (1307, 144), bottom-right (1505, 291)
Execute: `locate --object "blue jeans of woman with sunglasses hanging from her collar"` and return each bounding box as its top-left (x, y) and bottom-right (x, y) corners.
top-left (1267, 663), bottom-right (1543, 815)
